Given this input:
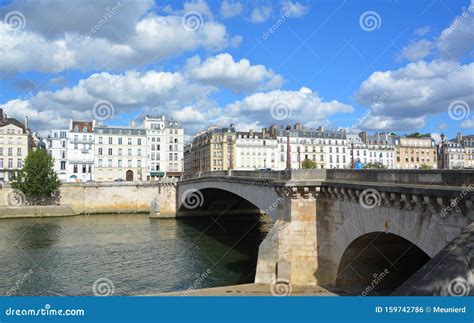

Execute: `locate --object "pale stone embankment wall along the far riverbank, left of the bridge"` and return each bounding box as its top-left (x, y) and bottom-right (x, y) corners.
top-left (0, 182), bottom-right (176, 217)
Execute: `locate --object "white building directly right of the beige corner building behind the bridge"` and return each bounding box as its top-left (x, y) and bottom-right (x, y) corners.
top-left (234, 130), bottom-right (278, 170)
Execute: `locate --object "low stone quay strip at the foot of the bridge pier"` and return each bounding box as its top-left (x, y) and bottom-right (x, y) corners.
top-left (154, 282), bottom-right (345, 296)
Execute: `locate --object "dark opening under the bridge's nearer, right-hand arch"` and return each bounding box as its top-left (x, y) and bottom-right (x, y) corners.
top-left (336, 232), bottom-right (430, 296)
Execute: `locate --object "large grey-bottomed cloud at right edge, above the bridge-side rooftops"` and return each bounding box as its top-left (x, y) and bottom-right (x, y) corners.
top-left (355, 60), bottom-right (474, 130)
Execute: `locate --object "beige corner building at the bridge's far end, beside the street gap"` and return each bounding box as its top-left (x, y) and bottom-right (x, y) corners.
top-left (190, 124), bottom-right (236, 173)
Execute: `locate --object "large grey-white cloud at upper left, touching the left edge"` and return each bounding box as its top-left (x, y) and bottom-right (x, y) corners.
top-left (0, 3), bottom-right (242, 73)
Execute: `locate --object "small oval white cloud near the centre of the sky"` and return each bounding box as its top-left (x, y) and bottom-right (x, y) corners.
top-left (185, 54), bottom-right (283, 92)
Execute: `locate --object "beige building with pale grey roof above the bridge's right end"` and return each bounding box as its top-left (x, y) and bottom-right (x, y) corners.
top-left (394, 136), bottom-right (438, 169)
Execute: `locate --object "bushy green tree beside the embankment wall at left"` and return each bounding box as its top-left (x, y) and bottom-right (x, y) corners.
top-left (12, 149), bottom-right (61, 205)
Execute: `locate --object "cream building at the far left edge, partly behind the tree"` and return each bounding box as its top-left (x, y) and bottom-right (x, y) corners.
top-left (0, 109), bottom-right (33, 182)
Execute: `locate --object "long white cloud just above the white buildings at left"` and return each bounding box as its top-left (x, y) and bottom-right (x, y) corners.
top-left (2, 71), bottom-right (213, 130)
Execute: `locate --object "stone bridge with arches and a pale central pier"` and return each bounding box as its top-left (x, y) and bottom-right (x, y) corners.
top-left (177, 170), bottom-right (474, 293)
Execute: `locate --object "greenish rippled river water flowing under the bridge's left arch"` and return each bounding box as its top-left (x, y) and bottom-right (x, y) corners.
top-left (0, 214), bottom-right (271, 295)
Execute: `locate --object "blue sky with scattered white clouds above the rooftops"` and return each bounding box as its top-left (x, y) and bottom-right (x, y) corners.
top-left (0, 0), bottom-right (474, 142)
